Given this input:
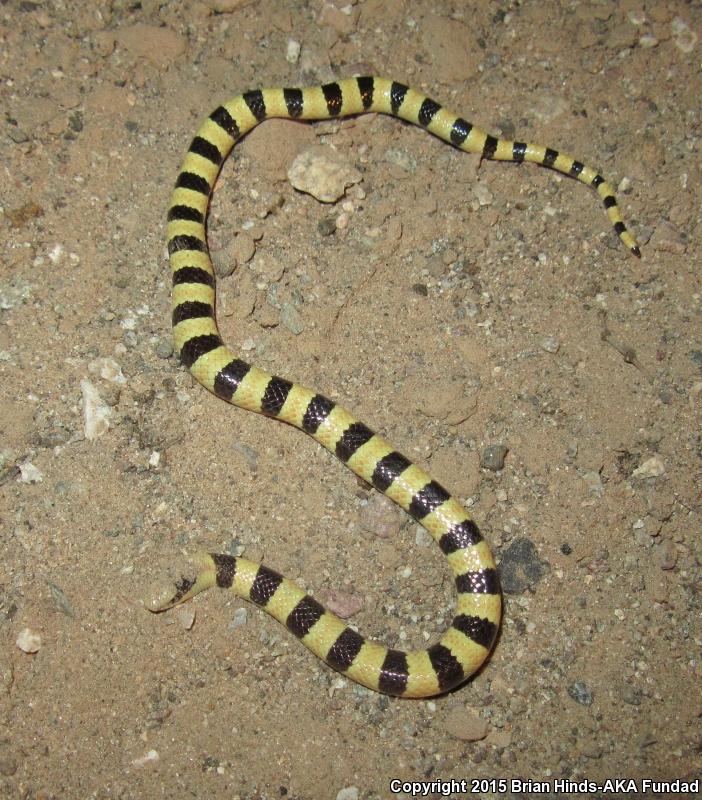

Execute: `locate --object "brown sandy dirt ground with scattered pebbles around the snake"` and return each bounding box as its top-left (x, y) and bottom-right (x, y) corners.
top-left (0, 0), bottom-right (702, 800)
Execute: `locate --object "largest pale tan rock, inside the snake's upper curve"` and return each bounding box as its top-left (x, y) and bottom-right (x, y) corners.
top-left (288, 145), bottom-right (362, 203)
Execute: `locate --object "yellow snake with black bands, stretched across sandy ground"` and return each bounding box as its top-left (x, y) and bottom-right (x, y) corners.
top-left (146, 76), bottom-right (641, 698)
